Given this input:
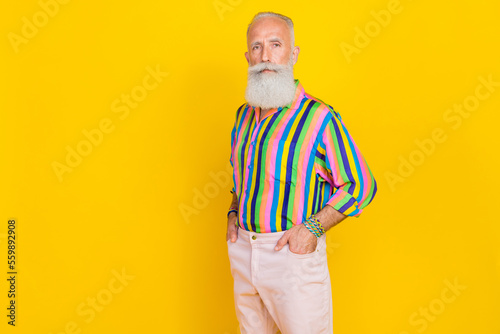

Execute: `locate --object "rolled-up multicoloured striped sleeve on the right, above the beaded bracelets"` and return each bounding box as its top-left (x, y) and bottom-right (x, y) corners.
top-left (316, 110), bottom-right (377, 217)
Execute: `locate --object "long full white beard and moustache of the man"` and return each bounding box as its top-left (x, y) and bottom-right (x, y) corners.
top-left (245, 58), bottom-right (295, 109)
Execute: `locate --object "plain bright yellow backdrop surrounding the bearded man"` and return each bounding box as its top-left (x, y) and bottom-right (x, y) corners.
top-left (0, 0), bottom-right (500, 334)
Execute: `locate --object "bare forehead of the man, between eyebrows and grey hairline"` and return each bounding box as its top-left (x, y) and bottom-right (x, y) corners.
top-left (247, 16), bottom-right (291, 43)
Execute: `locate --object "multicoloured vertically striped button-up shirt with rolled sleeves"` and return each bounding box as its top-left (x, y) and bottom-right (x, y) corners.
top-left (230, 80), bottom-right (377, 233)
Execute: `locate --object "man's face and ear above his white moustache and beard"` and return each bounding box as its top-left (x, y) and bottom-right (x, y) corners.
top-left (245, 17), bottom-right (299, 69)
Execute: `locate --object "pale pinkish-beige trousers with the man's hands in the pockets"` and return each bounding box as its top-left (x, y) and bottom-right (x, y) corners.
top-left (227, 228), bottom-right (333, 334)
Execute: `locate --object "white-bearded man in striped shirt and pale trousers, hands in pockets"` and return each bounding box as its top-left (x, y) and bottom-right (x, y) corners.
top-left (226, 12), bottom-right (376, 334)
